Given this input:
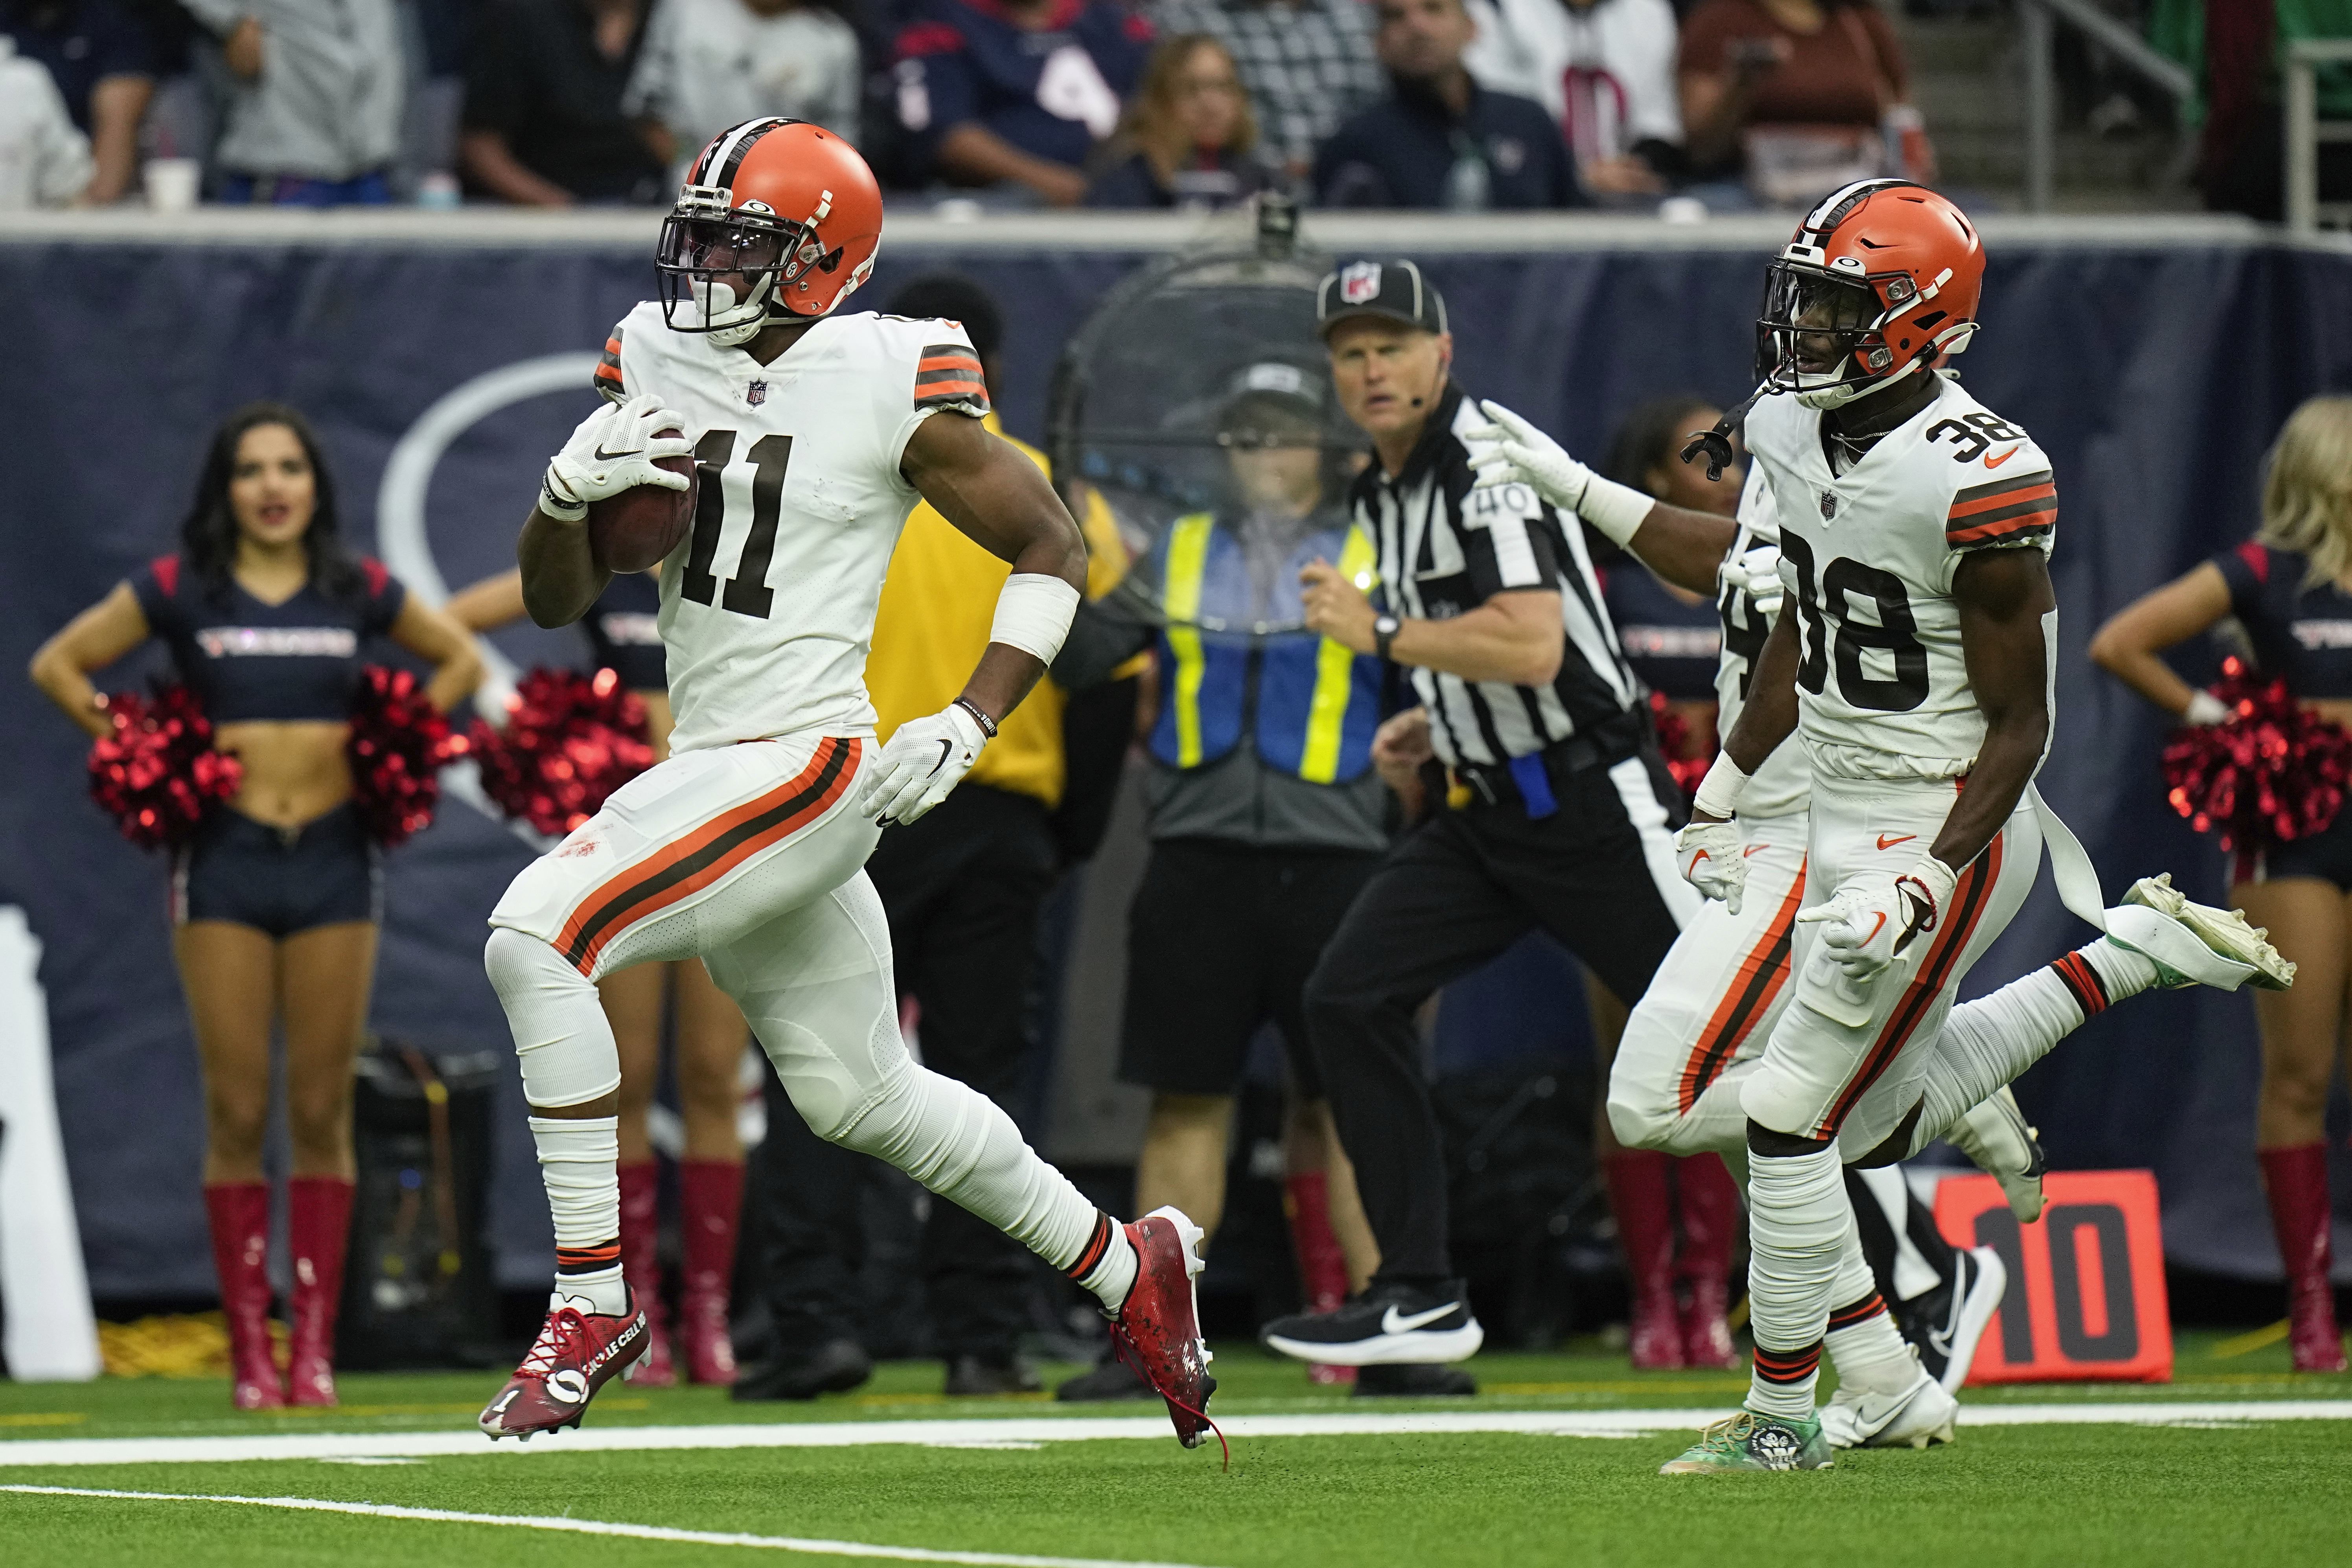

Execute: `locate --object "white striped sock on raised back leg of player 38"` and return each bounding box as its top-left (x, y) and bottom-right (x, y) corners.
top-left (1898, 938), bottom-right (2157, 1161)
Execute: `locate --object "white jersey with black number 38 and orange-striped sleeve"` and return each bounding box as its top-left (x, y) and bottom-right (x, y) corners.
top-left (1748, 379), bottom-right (2058, 778)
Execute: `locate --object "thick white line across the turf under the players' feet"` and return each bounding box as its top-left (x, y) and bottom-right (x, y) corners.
top-left (0, 1399), bottom-right (2352, 1469)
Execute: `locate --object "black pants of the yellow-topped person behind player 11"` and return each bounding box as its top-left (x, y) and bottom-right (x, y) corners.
top-left (748, 783), bottom-right (1056, 1364)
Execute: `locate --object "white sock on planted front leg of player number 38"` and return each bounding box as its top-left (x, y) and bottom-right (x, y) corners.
top-left (1748, 1145), bottom-right (1868, 1420)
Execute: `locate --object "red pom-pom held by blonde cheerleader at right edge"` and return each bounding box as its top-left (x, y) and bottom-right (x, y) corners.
top-left (2164, 658), bottom-right (2352, 853)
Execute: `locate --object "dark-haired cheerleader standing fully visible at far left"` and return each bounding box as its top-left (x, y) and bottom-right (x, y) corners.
top-left (33, 402), bottom-right (482, 1410)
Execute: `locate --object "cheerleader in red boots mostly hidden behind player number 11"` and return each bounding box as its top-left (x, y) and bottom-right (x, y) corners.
top-left (449, 571), bottom-right (750, 1385)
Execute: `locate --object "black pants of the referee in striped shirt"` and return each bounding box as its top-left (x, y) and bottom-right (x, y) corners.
top-left (1308, 757), bottom-right (1679, 1286)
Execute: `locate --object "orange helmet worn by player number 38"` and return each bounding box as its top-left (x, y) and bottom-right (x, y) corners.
top-left (1757, 179), bottom-right (1985, 409)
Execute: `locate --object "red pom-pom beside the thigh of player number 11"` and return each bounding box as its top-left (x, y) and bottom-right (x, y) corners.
top-left (473, 670), bottom-right (654, 837)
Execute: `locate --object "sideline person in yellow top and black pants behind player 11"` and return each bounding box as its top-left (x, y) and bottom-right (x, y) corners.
top-left (734, 275), bottom-right (1126, 1399)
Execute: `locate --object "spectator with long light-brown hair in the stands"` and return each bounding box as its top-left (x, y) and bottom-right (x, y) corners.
top-left (1087, 33), bottom-right (1275, 207)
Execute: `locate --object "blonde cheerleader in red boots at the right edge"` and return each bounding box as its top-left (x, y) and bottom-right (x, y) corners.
top-left (2091, 397), bottom-right (2352, 1373)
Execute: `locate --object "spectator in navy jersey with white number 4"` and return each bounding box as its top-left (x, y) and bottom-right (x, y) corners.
top-left (896, 0), bottom-right (1152, 207)
